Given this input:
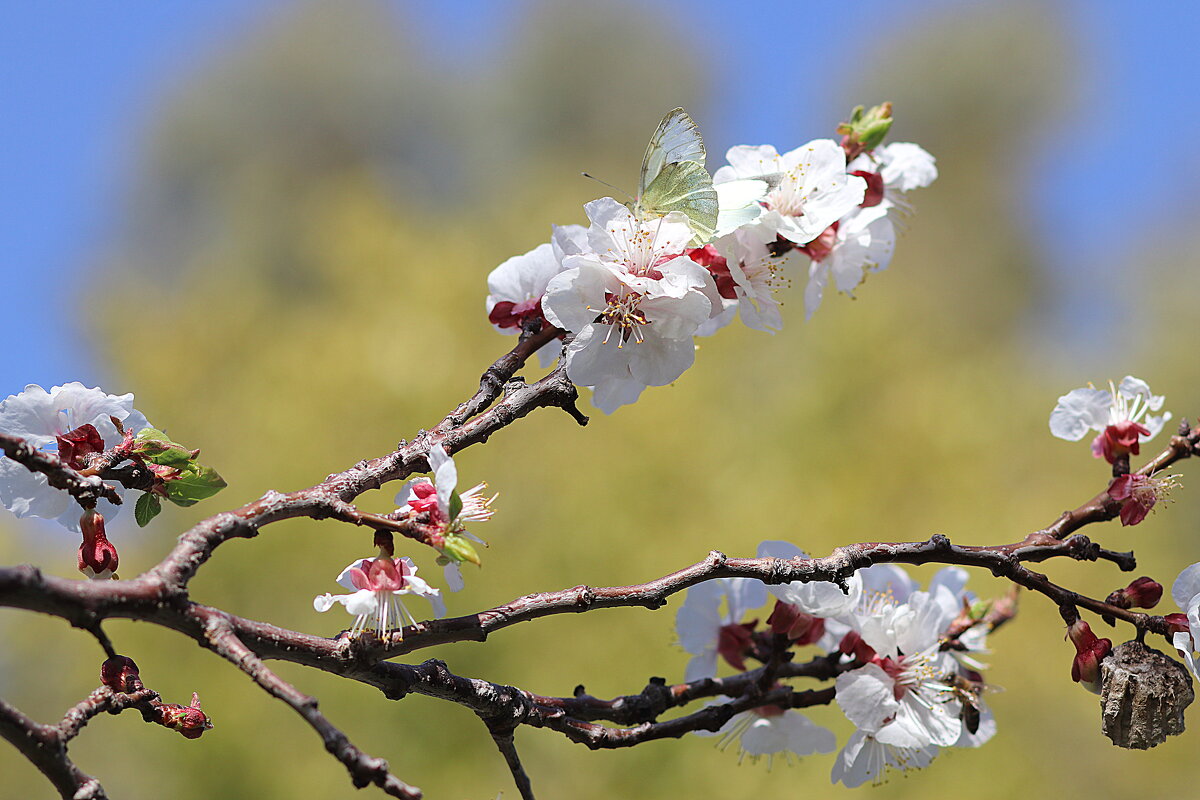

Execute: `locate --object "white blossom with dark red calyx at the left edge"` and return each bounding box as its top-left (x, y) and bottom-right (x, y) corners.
top-left (0, 381), bottom-right (149, 531)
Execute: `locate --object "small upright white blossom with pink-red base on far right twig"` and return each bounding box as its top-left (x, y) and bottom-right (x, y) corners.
top-left (1050, 375), bottom-right (1171, 465)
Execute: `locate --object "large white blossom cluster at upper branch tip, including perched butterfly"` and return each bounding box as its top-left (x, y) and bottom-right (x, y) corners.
top-left (487, 104), bottom-right (937, 413)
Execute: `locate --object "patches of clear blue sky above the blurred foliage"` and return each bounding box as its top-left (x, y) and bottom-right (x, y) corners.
top-left (0, 0), bottom-right (1200, 397)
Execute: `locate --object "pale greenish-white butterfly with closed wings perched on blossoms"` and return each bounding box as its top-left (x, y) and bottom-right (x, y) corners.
top-left (628, 108), bottom-right (718, 245)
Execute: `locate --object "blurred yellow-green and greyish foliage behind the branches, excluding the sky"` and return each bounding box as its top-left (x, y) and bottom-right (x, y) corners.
top-left (0, 2), bottom-right (1200, 800)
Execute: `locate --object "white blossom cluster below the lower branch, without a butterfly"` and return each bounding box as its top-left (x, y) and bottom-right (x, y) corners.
top-left (676, 541), bottom-right (1010, 787)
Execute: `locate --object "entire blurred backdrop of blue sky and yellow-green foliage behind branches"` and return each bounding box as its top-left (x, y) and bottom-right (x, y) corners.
top-left (0, 0), bottom-right (1200, 800)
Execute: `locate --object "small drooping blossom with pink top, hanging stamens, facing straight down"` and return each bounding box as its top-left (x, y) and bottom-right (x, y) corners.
top-left (312, 555), bottom-right (445, 637)
